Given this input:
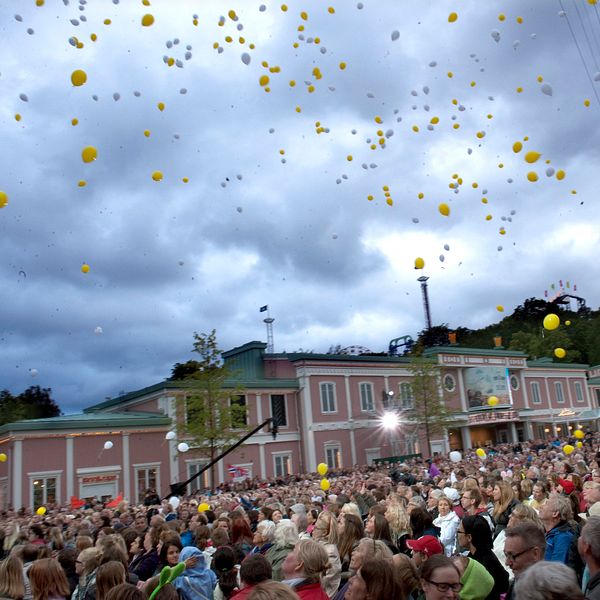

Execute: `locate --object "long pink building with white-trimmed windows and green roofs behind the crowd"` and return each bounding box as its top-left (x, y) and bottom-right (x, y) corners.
top-left (0, 342), bottom-right (600, 508)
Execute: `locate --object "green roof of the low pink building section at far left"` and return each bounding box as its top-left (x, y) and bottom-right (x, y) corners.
top-left (0, 412), bottom-right (171, 434)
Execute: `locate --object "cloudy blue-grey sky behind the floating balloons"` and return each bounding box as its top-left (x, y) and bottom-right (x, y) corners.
top-left (0, 0), bottom-right (600, 412)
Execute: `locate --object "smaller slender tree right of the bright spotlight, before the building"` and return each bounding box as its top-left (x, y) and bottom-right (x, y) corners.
top-left (409, 357), bottom-right (453, 453)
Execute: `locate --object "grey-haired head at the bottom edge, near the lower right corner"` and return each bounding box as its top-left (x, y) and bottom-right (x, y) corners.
top-left (515, 560), bottom-right (583, 600)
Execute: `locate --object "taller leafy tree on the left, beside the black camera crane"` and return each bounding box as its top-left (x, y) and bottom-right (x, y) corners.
top-left (173, 329), bottom-right (247, 489)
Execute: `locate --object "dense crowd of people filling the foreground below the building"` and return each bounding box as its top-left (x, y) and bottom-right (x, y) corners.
top-left (0, 433), bottom-right (600, 600)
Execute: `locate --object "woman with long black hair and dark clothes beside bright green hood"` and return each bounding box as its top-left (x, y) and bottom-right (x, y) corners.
top-left (458, 512), bottom-right (512, 600)
